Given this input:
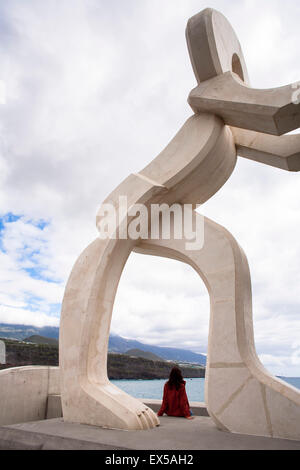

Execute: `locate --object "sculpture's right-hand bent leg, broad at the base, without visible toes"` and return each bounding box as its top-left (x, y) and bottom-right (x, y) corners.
top-left (135, 215), bottom-right (300, 439)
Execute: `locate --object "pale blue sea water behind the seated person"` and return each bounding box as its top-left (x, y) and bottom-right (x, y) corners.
top-left (111, 377), bottom-right (300, 401)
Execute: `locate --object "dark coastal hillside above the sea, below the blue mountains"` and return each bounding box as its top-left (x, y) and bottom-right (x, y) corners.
top-left (0, 338), bottom-right (205, 379)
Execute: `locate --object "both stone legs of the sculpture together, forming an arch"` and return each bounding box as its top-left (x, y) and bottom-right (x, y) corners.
top-left (60, 208), bottom-right (300, 439)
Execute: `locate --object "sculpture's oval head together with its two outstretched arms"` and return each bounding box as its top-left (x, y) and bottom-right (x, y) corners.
top-left (186, 8), bottom-right (300, 171)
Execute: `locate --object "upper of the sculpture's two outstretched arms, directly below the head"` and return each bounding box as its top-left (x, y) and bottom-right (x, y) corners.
top-left (188, 72), bottom-right (300, 135)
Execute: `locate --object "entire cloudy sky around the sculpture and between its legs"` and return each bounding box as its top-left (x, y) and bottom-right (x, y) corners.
top-left (0, 0), bottom-right (300, 377)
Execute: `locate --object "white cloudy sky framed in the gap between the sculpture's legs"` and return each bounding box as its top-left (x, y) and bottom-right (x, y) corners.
top-left (111, 253), bottom-right (209, 352)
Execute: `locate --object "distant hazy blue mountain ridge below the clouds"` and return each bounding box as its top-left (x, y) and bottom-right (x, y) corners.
top-left (0, 323), bottom-right (206, 366)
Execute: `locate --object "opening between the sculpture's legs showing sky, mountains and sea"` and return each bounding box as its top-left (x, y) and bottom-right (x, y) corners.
top-left (108, 252), bottom-right (210, 401)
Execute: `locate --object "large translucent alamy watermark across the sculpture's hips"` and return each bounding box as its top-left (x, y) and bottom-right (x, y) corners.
top-left (97, 196), bottom-right (204, 250)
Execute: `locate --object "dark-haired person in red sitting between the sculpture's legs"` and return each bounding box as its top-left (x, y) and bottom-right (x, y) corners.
top-left (157, 367), bottom-right (193, 419)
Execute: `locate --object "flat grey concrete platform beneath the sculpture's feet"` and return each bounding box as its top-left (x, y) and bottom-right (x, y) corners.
top-left (0, 416), bottom-right (300, 450)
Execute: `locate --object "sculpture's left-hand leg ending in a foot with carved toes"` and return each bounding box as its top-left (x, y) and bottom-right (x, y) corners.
top-left (60, 235), bottom-right (159, 429)
